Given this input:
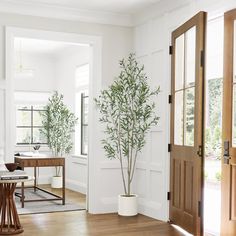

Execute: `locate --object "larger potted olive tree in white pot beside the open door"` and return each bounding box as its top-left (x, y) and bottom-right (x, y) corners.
top-left (95, 54), bottom-right (159, 216)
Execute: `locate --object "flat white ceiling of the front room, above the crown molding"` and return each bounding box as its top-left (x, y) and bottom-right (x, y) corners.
top-left (10, 0), bottom-right (161, 14)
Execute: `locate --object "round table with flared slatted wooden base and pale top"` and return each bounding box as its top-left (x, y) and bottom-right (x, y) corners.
top-left (0, 177), bottom-right (33, 235)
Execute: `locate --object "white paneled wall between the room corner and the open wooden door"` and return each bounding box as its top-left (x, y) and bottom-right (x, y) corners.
top-left (134, 0), bottom-right (236, 220)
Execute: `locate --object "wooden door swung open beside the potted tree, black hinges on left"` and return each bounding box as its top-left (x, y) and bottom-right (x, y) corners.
top-left (170, 12), bottom-right (206, 235)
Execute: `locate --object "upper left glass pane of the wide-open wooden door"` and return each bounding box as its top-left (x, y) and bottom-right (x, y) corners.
top-left (175, 34), bottom-right (184, 90)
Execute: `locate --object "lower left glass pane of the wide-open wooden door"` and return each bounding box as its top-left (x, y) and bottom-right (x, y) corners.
top-left (174, 91), bottom-right (183, 145)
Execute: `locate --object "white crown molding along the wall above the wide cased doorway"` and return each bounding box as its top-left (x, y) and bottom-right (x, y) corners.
top-left (0, 0), bottom-right (133, 27)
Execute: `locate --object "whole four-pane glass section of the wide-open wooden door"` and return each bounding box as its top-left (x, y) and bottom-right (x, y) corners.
top-left (174, 27), bottom-right (196, 146)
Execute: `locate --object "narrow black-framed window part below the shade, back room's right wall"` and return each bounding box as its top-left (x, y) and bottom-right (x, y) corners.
top-left (81, 93), bottom-right (88, 155)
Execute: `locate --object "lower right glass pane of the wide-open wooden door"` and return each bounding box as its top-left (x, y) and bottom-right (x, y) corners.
top-left (184, 87), bottom-right (195, 146)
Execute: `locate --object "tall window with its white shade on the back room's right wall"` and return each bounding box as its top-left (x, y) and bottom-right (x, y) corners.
top-left (75, 64), bottom-right (89, 156)
